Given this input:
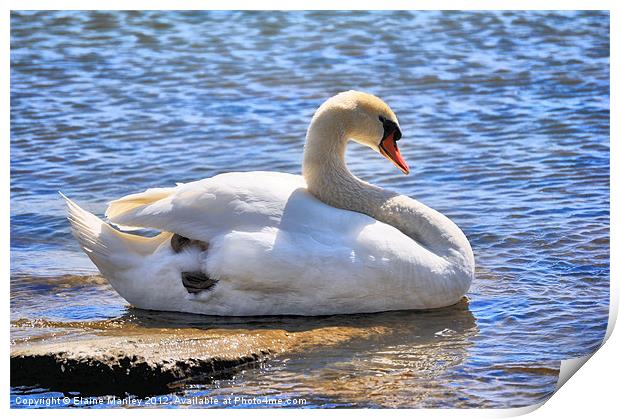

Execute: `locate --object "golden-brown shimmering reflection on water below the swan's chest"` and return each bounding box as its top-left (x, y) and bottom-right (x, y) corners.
top-left (191, 302), bottom-right (482, 407)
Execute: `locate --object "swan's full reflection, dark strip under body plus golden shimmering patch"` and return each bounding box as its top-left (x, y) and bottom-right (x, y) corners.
top-left (123, 298), bottom-right (483, 407)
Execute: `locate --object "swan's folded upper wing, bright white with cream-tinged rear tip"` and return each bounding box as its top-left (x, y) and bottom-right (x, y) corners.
top-left (106, 172), bottom-right (305, 241)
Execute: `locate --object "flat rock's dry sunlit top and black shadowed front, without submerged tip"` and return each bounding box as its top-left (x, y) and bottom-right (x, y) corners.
top-left (11, 332), bottom-right (273, 396)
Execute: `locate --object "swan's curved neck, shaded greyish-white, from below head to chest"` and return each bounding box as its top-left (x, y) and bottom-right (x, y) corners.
top-left (302, 111), bottom-right (473, 261)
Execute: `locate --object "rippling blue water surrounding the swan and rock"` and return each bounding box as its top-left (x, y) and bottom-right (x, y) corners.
top-left (11, 11), bottom-right (609, 407)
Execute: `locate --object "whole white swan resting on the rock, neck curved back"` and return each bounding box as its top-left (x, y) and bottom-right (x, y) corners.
top-left (61, 91), bottom-right (474, 316)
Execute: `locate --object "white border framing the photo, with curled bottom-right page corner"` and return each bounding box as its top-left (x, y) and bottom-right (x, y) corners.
top-left (0, 0), bottom-right (620, 418)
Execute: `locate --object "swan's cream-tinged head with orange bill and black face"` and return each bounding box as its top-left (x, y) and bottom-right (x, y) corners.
top-left (317, 90), bottom-right (409, 174)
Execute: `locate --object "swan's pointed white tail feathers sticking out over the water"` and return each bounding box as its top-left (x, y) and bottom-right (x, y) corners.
top-left (59, 192), bottom-right (171, 276)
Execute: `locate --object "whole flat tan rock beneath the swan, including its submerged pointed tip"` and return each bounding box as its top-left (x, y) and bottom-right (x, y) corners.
top-left (10, 321), bottom-right (386, 396)
